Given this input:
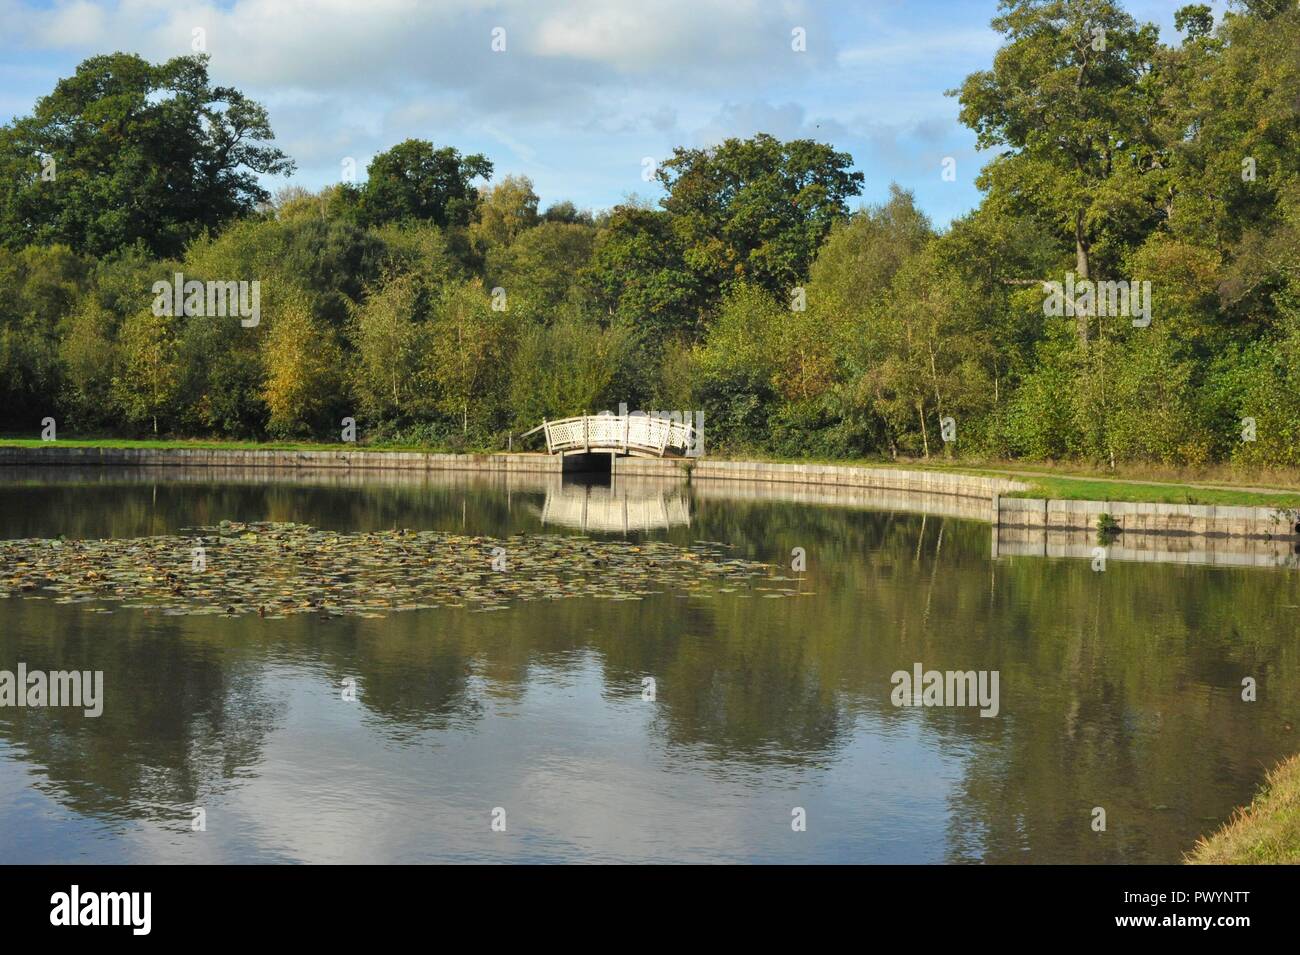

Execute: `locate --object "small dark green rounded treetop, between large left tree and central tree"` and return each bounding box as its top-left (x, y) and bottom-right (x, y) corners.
top-left (359, 139), bottom-right (491, 227)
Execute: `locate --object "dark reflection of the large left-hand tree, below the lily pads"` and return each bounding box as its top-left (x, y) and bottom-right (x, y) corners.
top-left (0, 599), bottom-right (285, 820)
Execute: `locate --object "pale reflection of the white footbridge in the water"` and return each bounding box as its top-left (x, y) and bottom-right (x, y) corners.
top-left (542, 482), bottom-right (690, 534)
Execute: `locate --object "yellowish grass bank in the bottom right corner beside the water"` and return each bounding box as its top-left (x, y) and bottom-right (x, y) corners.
top-left (1186, 756), bottom-right (1300, 865)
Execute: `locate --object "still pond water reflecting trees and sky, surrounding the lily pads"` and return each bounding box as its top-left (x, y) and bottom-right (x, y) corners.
top-left (0, 469), bottom-right (1300, 863)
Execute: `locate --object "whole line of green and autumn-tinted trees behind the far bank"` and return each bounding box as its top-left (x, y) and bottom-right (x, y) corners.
top-left (0, 0), bottom-right (1300, 466)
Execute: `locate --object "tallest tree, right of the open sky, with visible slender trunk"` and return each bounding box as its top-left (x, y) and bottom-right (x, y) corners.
top-left (950, 0), bottom-right (1162, 342)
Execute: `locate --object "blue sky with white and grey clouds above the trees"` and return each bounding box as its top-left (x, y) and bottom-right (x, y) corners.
top-left (0, 0), bottom-right (1226, 226)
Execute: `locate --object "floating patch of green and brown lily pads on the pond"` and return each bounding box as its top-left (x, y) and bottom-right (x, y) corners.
top-left (0, 521), bottom-right (800, 618)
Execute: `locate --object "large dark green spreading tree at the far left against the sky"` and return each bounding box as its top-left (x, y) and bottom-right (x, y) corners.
top-left (0, 53), bottom-right (294, 256)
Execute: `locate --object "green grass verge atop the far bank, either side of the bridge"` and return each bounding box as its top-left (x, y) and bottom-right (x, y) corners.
top-left (0, 438), bottom-right (1300, 508)
